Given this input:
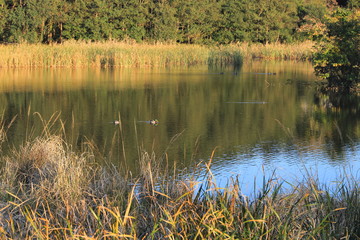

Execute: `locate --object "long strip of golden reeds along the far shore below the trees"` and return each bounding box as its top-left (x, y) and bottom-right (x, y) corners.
top-left (0, 42), bottom-right (312, 68)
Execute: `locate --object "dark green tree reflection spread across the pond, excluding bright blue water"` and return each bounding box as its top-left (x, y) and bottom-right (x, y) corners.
top-left (0, 62), bottom-right (360, 176)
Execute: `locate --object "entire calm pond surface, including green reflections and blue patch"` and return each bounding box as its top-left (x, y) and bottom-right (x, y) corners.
top-left (0, 61), bottom-right (360, 192)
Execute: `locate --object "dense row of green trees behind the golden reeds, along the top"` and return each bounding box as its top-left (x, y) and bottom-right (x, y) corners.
top-left (0, 0), bottom-right (358, 44)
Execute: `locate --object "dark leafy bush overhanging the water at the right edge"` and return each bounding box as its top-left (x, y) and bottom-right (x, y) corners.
top-left (314, 9), bottom-right (360, 90)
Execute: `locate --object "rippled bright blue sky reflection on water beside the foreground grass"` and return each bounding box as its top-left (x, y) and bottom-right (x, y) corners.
top-left (198, 144), bottom-right (360, 195)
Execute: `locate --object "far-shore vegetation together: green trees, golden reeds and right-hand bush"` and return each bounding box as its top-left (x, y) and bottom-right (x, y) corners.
top-left (0, 0), bottom-right (360, 86)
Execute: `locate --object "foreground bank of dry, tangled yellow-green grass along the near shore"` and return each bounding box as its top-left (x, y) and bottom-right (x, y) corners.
top-left (0, 124), bottom-right (360, 239)
